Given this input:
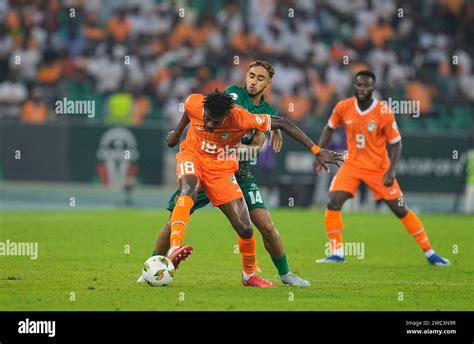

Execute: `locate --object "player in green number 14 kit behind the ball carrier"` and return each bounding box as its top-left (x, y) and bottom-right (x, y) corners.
top-left (154, 60), bottom-right (310, 286)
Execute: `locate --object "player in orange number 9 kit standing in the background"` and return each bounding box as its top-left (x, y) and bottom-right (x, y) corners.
top-left (316, 71), bottom-right (450, 266)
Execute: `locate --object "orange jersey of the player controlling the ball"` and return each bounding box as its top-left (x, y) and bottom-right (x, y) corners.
top-left (180, 93), bottom-right (271, 169)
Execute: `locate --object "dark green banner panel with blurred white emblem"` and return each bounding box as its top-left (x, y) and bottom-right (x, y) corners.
top-left (68, 126), bottom-right (164, 187)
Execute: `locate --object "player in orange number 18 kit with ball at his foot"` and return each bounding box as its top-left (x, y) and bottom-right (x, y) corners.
top-left (168, 91), bottom-right (343, 288)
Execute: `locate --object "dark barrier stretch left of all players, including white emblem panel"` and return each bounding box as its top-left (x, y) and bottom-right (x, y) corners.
top-left (0, 123), bottom-right (164, 184)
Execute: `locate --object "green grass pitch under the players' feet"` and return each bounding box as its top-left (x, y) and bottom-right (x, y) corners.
top-left (0, 209), bottom-right (474, 311)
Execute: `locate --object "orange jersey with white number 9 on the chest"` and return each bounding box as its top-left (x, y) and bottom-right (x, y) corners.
top-left (328, 97), bottom-right (401, 170)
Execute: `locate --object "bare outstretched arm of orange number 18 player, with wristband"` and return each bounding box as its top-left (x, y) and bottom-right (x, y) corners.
top-left (271, 117), bottom-right (344, 173)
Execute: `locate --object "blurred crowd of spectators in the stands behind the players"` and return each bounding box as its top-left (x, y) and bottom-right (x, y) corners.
top-left (0, 0), bottom-right (474, 130)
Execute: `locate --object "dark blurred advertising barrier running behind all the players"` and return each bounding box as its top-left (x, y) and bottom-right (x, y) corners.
top-left (0, 123), bottom-right (468, 195)
